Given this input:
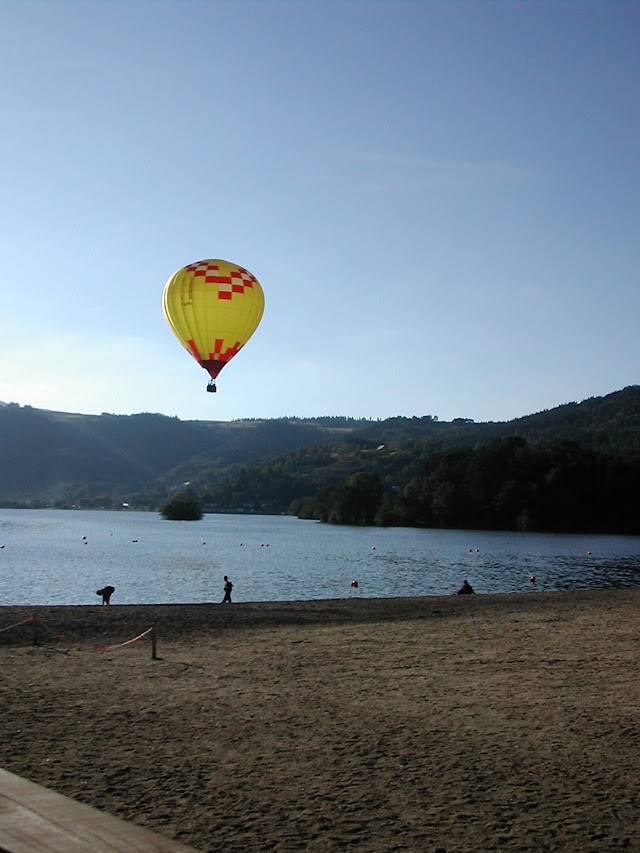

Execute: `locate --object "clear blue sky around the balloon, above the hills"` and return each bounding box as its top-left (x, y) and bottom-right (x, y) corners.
top-left (0, 0), bottom-right (640, 421)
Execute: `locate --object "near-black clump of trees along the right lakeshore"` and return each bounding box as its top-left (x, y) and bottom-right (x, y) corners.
top-left (291, 436), bottom-right (640, 534)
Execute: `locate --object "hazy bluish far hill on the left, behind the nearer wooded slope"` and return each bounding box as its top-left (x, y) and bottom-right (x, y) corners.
top-left (0, 404), bottom-right (344, 506)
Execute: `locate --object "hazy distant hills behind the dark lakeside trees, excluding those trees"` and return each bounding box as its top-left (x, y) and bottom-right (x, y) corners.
top-left (0, 386), bottom-right (640, 511)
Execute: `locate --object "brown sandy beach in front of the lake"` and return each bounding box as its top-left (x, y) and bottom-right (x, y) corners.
top-left (0, 590), bottom-right (640, 853)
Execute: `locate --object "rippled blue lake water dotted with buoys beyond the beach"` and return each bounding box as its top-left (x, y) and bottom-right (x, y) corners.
top-left (0, 509), bottom-right (640, 605)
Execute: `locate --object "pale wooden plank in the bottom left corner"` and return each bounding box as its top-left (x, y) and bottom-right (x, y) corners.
top-left (0, 769), bottom-right (195, 853)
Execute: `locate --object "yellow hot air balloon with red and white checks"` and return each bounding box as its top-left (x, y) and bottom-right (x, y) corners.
top-left (162, 260), bottom-right (264, 391)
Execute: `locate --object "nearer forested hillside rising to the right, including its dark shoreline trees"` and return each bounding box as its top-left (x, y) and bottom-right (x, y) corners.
top-left (190, 388), bottom-right (640, 533)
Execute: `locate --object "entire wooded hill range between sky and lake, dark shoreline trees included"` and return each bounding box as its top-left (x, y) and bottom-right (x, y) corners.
top-left (0, 386), bottom-right (640, 532)
